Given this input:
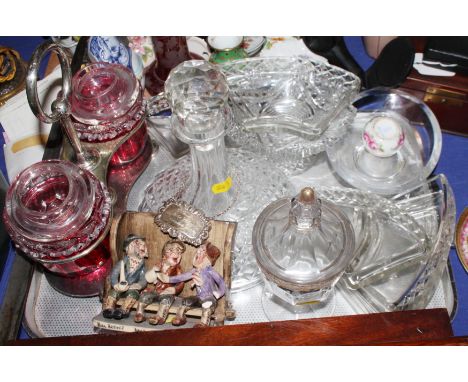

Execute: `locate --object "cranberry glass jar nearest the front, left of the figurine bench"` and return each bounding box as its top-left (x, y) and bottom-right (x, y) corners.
top-left (3, 160), bottom-right (111, 297)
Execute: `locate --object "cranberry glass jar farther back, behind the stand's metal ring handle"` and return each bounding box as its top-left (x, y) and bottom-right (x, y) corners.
top-left (71, 62), bottom-right (150, 171)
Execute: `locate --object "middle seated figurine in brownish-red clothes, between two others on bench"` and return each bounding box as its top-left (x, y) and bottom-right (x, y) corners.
top-left (134, 240), bottom-right (185, 325)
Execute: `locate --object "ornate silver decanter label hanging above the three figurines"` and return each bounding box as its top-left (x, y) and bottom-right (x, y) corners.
top-left (154, 199), bottom-right (211, 246)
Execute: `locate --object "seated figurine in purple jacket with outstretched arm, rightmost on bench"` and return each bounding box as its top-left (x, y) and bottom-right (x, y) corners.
top-left (158, 242), bottom-right (226, 327)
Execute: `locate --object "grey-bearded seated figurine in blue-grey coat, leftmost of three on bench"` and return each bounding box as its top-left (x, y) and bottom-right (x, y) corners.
top-left (102, 234), bottom-right (148, 320)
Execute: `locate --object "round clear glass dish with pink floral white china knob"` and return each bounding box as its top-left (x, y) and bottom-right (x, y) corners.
top-left (327, 89), bottom-right (442, 195)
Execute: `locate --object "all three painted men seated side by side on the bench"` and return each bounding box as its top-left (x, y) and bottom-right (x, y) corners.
top-left (102, 234), bottom-right (226, 327)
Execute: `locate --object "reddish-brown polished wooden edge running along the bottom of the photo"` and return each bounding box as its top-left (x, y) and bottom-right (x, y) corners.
top-left (9, 309), bottom-right (454, 346)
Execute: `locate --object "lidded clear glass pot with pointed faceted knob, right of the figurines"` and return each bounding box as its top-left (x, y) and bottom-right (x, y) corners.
top-left (252, 187), bottom-right (354, 308)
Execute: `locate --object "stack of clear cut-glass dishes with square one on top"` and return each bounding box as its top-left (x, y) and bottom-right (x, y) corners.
top-left (221, 57), bottom-right (361, 174)
